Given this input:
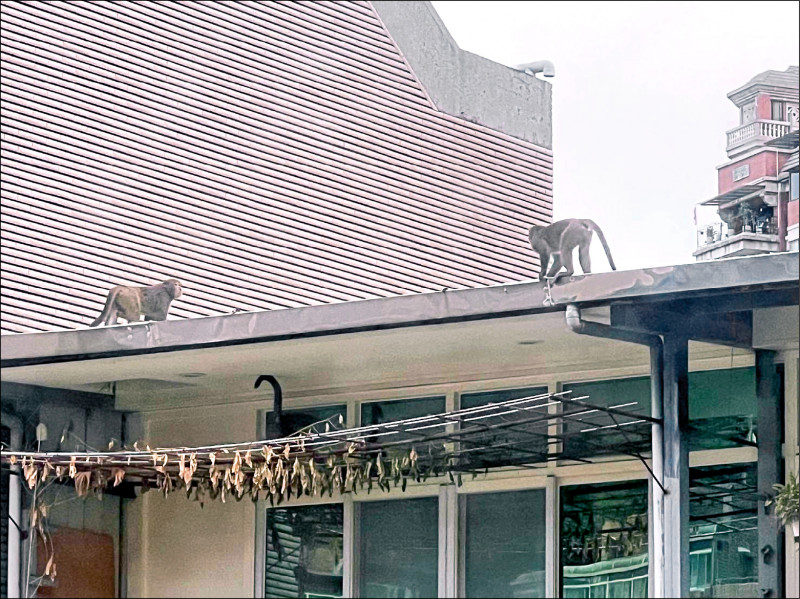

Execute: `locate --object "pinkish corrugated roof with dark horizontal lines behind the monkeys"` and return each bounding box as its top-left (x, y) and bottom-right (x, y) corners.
top-left (2, 2), bottom-right (552, 332)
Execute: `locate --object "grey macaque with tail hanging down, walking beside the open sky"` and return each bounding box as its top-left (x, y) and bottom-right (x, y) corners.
top-left (529, 218), bottom-right (617, 279)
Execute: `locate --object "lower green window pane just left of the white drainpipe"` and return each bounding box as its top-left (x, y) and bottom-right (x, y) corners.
top-left (560, 480), bottom-right (648, 597)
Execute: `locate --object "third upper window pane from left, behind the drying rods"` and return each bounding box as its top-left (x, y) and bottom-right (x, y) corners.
top-left (461, 387), bottom-right (548, 468)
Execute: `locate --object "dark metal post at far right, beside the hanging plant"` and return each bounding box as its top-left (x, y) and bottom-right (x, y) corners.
top-left (756, 350), bottom-right (784, 597)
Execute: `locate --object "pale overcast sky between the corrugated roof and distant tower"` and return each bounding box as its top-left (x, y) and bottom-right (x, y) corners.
top-left (433, 0), bottom-right (800, 272)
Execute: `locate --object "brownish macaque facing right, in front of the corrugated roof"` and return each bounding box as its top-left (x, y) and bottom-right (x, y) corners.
top-left (89, 279), bottom-right (182, 327)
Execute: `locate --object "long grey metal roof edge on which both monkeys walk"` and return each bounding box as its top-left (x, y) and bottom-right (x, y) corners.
top-left (0, 252), bottom-right (800, 368)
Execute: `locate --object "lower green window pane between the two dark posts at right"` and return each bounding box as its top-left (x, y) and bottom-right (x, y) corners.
top-left (689, 463), bottom-right (759, 597)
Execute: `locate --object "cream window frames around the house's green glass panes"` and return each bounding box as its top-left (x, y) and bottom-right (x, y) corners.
top-left (254, 364), bottom-right (757, 597)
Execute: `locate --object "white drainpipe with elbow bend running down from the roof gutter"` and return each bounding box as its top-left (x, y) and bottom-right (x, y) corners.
top-left (566, 304), bottom-right (664, 597)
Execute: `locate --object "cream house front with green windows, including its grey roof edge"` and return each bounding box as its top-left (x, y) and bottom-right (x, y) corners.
top-left (0, 254), bottom-right (800, 598)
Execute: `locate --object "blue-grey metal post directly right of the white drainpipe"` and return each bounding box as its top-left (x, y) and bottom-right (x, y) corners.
top-left (663, 334), bottom-right (689, 597)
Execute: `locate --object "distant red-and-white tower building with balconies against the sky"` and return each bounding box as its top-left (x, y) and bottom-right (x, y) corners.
top-left (694, 66), bottom-right (800, 260)
